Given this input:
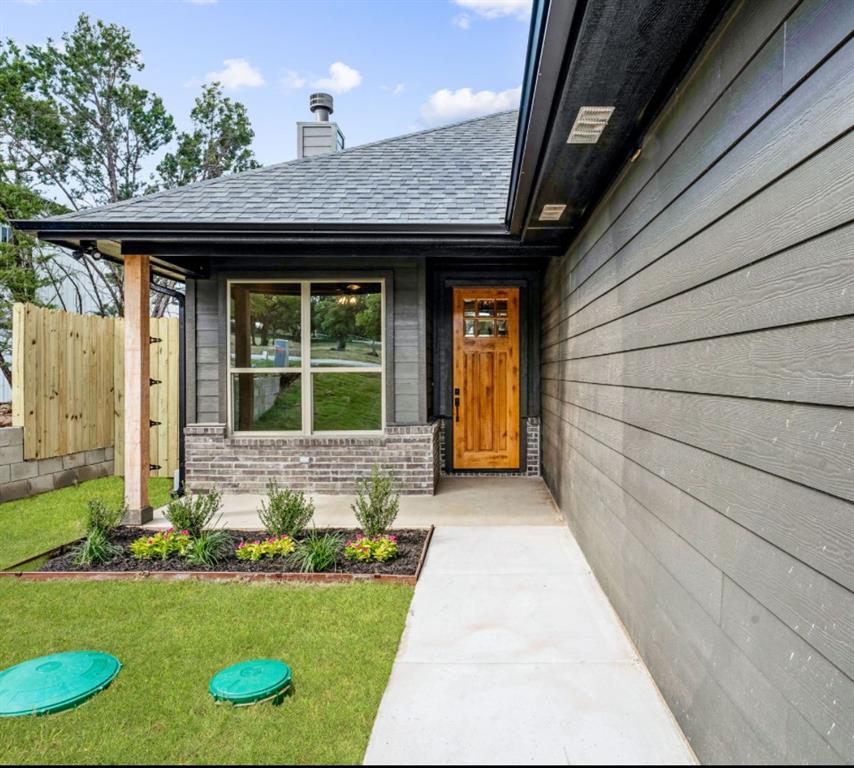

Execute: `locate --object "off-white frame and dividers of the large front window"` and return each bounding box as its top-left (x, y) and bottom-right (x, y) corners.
top-left (225, 276), bottom-right (386, 439)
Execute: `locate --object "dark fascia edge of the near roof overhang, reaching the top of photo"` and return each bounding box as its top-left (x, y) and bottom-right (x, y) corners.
top-left (507, 0), bottom-right (585, 235)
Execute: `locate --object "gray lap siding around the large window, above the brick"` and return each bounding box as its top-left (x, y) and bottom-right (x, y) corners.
top-left (188, 259), bottom-right (427, 425)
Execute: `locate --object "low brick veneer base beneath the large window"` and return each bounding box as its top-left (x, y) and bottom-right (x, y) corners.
top-left (184, 424), bottom-right (439, 494)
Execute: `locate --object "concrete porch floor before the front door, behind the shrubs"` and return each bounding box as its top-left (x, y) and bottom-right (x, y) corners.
top-left (147, 476), bottom-right (563, 529)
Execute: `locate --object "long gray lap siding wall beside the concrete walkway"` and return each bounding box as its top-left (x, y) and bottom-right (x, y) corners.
top-left (542, 0), bottom-right (854, 763)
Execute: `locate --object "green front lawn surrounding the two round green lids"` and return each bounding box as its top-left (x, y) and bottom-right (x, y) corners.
top-left (0, 579), bottom-right (412, 764)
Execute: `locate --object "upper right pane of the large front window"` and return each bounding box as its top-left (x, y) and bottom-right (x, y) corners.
top-left (311, 283), bottom-right (382, 368)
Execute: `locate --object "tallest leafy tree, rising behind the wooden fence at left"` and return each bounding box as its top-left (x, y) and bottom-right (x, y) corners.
top-left (0, 14), bottom-right (174, 315)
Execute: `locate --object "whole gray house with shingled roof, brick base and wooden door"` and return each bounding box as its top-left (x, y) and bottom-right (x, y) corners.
top-left (13, 0), bottom-right (854, 762)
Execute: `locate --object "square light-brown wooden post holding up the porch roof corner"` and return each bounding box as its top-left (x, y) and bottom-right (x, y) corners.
top-left (124, 256), bottom-right (153, 525)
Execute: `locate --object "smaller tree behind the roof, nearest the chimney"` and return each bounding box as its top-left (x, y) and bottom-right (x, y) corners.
top-left (157, 83), bottom-right (259, 188)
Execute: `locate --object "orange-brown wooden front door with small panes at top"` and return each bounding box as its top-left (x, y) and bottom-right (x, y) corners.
top-left (451, 288), bottom-right (519, 469)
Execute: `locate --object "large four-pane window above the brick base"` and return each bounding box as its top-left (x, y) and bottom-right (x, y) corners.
top-left (228, 280), bottom-right (385, 434)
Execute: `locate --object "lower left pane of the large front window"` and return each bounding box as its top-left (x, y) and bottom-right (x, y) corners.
top-left (231, 373), bottom-right (302, 432)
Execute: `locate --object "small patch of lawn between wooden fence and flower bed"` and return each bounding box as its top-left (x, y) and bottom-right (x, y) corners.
top-left (0, 477), bottom-right (172, 570)
